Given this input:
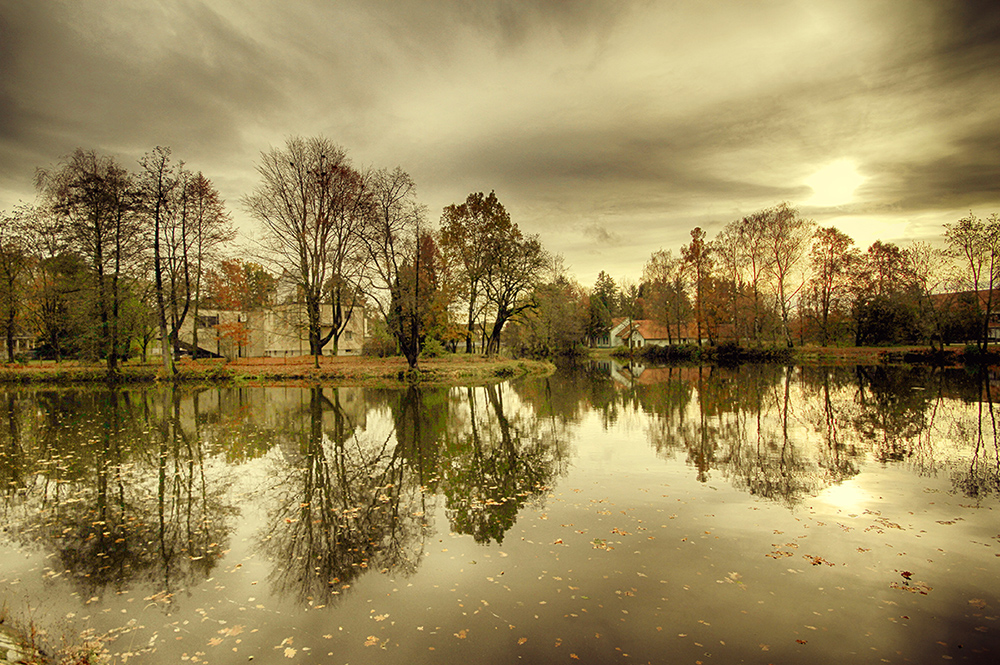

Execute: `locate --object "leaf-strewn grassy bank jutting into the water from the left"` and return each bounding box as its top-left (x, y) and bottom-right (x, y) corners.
top-left (0, 354), bottom-right (555, 385)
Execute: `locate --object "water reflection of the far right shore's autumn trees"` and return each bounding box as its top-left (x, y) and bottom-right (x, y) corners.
top-left (581, 363), bottom-right (1000, 505)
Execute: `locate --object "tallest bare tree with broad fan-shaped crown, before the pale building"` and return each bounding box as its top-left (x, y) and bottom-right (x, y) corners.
top-left (243, 137), bottom-right (370, 366)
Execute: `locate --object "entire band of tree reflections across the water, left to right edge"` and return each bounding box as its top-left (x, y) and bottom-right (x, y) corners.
top-left (0, 364), bottom-right (1000, 611)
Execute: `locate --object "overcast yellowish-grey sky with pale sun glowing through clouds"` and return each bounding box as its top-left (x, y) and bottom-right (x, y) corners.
top-left (0, 0), bottom-right (1000, 286)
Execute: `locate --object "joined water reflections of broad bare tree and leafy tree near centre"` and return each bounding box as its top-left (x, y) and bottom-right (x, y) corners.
top-left (260, 385), bottom-right (564, 605)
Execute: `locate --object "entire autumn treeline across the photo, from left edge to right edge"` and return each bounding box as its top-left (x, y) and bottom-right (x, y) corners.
top-left (0, 137), bottom-right (1000, 376)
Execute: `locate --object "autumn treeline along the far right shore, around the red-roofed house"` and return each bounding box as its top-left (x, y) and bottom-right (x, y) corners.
top-left (511, 203), bottom-right (1000, 352)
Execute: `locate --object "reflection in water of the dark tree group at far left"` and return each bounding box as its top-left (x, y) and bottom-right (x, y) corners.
top-left (3, 389), bottom-right (232, 606)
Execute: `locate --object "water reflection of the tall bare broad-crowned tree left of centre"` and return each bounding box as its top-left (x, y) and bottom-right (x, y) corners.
top-left (261, 387), bottom-right (427, 604)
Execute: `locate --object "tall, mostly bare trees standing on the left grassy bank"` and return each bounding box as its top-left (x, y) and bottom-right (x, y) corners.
top-left (0, 137), bottom-right (551, 376)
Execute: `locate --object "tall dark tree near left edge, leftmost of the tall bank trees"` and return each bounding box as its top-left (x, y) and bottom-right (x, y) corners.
top-left (36, 149), bottom-right (149, 379)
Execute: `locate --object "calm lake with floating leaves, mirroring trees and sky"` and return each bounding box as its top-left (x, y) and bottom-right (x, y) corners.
top-left (0, 363), bottom-right (1000, 664)
